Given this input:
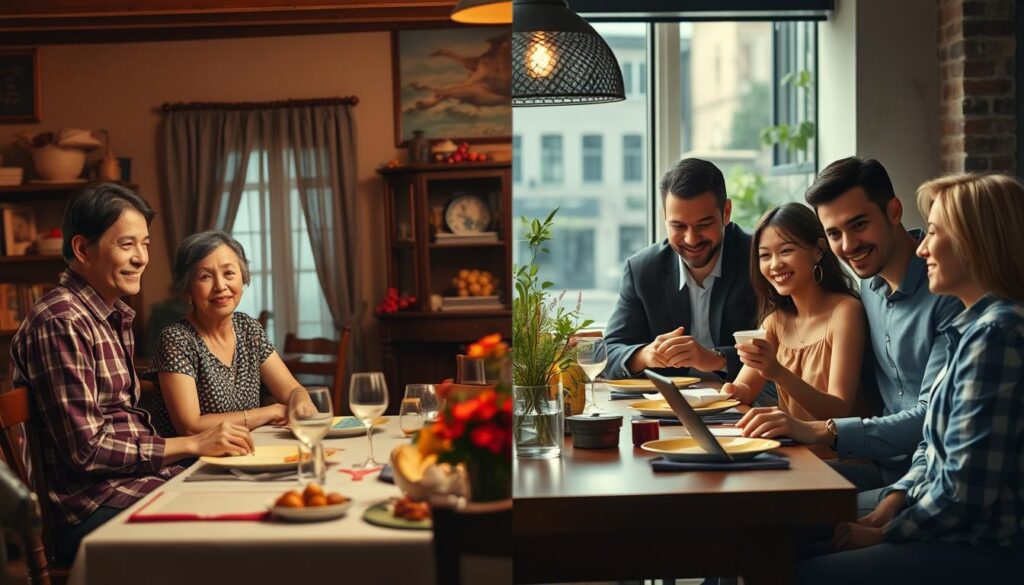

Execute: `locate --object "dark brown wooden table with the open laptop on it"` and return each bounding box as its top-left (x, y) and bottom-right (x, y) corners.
top-left (513, 383), bottom-right (856, 585)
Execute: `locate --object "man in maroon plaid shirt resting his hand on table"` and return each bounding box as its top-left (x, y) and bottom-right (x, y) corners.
top-left (11, 183), bottom-right (252, 563)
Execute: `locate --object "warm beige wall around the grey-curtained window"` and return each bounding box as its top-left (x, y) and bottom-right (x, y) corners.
top-left (0, 33), bottom-right (396, 367)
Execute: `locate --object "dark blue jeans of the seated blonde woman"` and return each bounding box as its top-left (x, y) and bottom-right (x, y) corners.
top-left (794, 540), bottom-right (1024, 585)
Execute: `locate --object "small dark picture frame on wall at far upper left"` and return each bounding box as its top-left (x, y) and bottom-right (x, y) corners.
top-left (0, 49), bottom-right (42, 124)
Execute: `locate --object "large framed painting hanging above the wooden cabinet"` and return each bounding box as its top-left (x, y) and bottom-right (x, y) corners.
top-left (391, 26), bottom-right (512, 147)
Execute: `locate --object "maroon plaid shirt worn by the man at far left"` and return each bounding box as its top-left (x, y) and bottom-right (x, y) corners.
top-left (10, 269), bottom-right (182, 525)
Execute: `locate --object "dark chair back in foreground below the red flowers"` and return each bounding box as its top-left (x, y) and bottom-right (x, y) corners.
top-left (430, 500), bottom-right (512, 585)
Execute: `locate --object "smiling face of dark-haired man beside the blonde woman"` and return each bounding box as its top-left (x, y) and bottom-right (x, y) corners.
top-left (817, 186), bottom-right (903, 279)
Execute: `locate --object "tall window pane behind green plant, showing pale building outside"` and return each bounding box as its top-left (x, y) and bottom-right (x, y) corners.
top-left (512, 24), bottom-right (653, 325)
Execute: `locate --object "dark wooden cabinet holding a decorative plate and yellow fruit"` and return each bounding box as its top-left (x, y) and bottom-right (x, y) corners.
top-left (378, 163), bottom-right (512, 408)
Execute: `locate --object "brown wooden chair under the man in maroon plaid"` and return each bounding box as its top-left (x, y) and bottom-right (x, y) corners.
top-left (0, 386), bottom-right (61, 585)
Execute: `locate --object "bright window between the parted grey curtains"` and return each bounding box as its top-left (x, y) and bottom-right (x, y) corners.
top-left (229, 153), bottom-right (336, 345)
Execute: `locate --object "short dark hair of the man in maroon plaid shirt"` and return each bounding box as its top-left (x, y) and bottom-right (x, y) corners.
top-left (60, 182), bottom-right (156, 262)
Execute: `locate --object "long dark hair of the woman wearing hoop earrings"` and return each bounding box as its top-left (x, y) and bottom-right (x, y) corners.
top-left (751, 203), bottom-right (860, 323)
